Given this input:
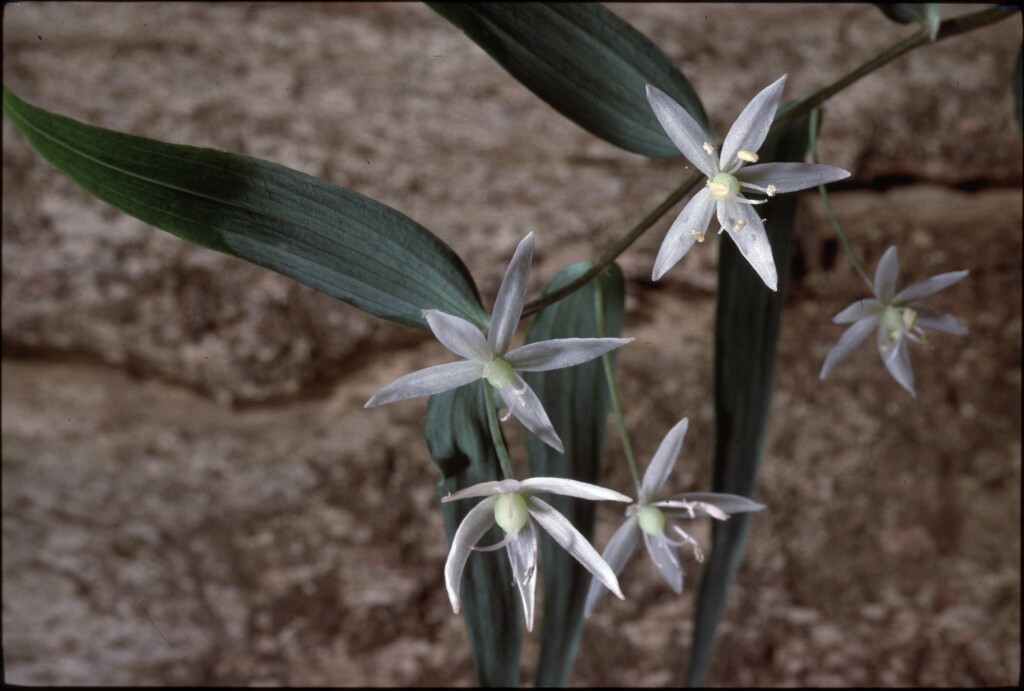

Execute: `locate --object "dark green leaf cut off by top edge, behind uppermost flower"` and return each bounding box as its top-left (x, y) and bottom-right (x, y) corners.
top-left (427, 2), bottom-right (713, 157)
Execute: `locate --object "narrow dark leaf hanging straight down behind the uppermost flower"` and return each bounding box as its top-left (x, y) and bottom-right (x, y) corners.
top-left (686, 106), bottom-right (810, 686)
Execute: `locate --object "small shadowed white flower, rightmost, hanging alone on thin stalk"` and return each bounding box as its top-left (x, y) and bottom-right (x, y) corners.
top-left (820, 246), bottom-right (968, 396)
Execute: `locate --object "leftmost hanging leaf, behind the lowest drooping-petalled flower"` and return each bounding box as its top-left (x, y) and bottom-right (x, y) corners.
top-left (423, 380), bottom-right (522, 686)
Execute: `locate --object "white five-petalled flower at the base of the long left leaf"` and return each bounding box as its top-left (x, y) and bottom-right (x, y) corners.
top-left (366, 233), bottom-right (633, 452)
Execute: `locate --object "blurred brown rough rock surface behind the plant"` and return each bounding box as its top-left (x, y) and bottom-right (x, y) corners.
top-left (2, 3), bottom-right (1022, 686)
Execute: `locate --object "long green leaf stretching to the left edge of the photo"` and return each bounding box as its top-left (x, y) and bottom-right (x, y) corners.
top-left (3, 88), bottom-right (487, 328)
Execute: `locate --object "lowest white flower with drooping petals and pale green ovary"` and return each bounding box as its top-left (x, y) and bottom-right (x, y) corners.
top-left (441, 477), bottom-right (633, 631)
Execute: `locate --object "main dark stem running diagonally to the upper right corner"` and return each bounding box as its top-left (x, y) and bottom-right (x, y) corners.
top-left (522, 7), bottom-right (1017, 316)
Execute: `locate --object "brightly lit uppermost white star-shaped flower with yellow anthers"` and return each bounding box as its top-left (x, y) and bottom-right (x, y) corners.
top-left (647, 75), bottom-right (850, 291)
